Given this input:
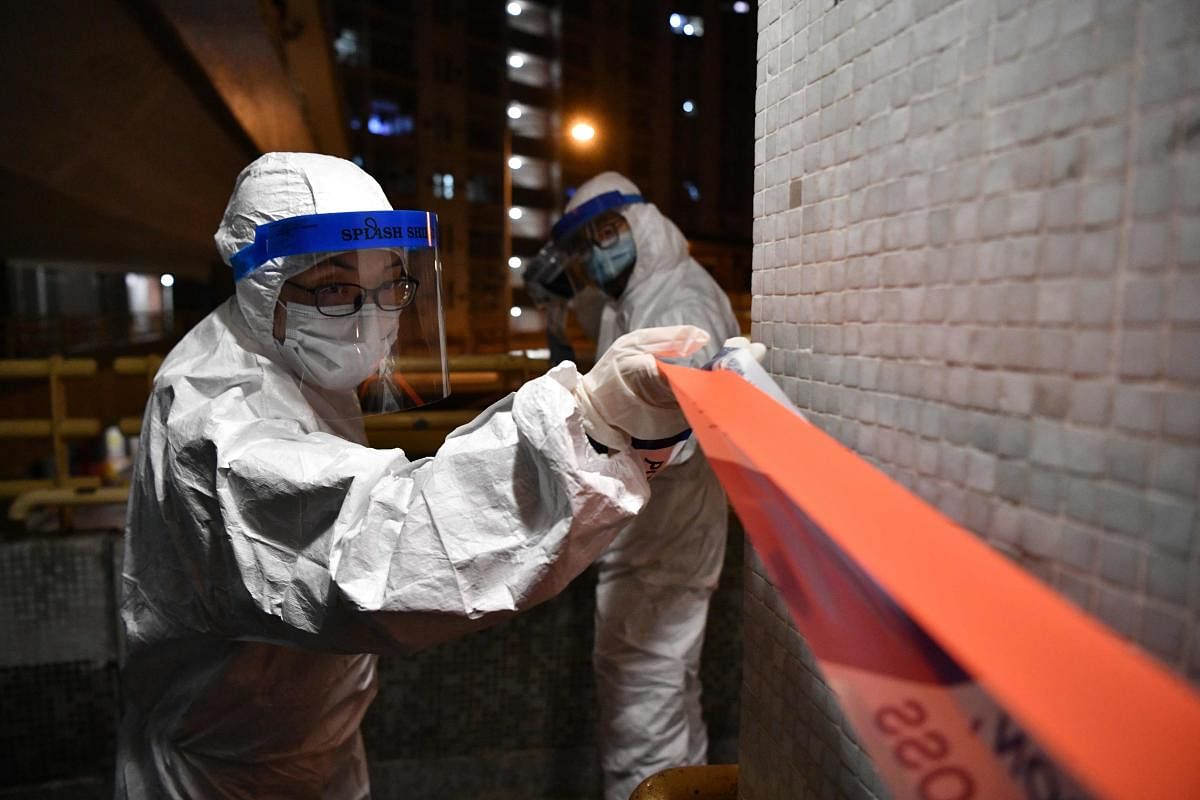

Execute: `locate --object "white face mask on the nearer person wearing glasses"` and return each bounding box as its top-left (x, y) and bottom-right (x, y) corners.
top-left (280, 301), bottom-right (400, 389)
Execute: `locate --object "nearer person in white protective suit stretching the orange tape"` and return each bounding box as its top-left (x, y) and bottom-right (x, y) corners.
top-left (115, 154), bottom-right (706, 799)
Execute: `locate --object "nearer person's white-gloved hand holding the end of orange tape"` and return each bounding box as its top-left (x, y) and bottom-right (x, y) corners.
top-left (575, 325), bottom-right (708, 450)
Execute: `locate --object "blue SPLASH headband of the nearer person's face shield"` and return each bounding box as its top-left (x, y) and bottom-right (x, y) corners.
top-left (229, 211), bottom-right (438, 281)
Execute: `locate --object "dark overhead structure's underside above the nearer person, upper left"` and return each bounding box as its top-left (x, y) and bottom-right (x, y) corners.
top-left (0, 0), bottom-right (349, 279)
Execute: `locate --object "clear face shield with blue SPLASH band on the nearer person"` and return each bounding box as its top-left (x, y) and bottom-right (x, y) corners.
top-left (233, 211), bottom-right (450, 415)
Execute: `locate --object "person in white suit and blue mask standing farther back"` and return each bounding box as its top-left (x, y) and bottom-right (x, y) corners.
top-left (526, 173), bottom-right (738, 800)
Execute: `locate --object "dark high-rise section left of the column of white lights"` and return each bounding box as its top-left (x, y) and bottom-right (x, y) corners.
top-left (330, 0), bottom-right (510, 351)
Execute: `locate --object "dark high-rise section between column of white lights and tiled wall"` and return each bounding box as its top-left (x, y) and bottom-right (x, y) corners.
top-left (552, 0), bottom-right (755, 291)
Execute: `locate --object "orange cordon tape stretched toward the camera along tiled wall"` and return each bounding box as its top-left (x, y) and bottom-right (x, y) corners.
top-left (661, 363), bottom-right (1200, 800)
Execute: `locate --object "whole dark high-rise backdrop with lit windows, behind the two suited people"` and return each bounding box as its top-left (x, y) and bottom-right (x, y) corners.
top-left (330, 0), bottom-right (755, 351)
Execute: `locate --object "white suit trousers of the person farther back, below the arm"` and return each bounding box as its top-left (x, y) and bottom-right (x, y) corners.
top-left (594, 452), bottom-right (727, 800)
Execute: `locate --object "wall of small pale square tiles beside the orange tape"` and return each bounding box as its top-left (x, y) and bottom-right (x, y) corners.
top-left (740, 0), bottom-right (1200, 800)
